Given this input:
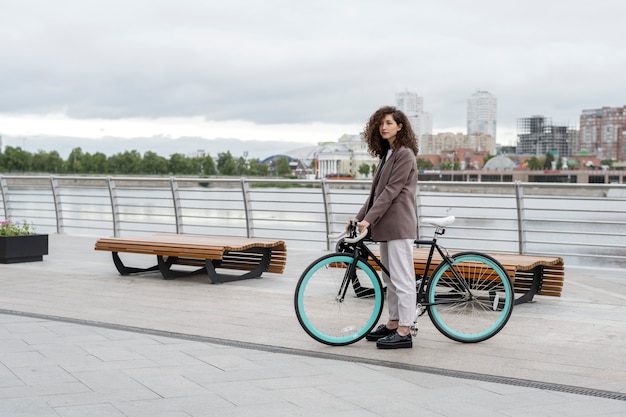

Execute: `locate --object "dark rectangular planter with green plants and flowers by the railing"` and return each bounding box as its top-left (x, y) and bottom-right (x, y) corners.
top-left (0, 219), bottom-right (48, 264)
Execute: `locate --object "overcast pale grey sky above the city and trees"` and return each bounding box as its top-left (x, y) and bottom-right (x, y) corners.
top-left (0, 0), bottom-right (626, 150)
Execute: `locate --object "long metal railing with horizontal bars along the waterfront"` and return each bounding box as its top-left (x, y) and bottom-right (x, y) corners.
top-left (0, 175), bottom-right (626, 267)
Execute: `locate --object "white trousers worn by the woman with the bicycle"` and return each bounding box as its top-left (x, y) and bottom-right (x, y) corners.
top-left (380, 239), bottom-right (417, 326)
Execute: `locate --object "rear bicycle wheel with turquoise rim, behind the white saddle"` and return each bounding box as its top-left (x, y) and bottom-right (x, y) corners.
top-left (427, 252), bottom-right (514, 343)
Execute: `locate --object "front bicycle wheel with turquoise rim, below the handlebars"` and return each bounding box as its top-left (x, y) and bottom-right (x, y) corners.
top-left (294, 253), bottom-right (384, 346)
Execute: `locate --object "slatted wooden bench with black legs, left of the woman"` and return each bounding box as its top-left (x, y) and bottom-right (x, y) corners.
top-left (95, 234), bottom-right (287, 283)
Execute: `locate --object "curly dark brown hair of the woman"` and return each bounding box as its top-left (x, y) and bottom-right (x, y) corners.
top-left (363, 106), bottom-right (418, 158)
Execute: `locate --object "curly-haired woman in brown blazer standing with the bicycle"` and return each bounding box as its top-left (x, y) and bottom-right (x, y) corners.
top-left (356, 106), bottom-right (417, 349)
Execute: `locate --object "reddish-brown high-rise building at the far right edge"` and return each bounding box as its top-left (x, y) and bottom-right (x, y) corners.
top-left (579, 106), bottom-right (626, 161)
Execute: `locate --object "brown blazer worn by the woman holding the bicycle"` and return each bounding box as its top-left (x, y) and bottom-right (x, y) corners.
top-left (356, 146), bottom-right (417, 242)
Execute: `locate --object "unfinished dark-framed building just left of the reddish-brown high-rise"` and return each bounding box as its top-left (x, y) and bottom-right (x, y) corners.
top-left (517, 116), bottom-right (578, 157)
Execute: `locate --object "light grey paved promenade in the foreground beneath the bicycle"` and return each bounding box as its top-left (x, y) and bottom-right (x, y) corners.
top-left (0, 235), bottom-right (626, 417)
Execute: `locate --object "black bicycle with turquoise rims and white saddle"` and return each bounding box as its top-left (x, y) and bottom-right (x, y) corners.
top-left (294, 216), bottom-right (514, 346)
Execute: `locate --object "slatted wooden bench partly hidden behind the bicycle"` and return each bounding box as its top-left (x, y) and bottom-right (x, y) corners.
top-left (370, 248), bottom-right (565, 304)
